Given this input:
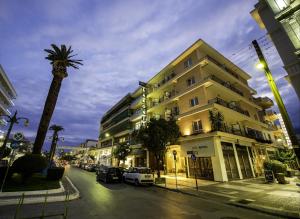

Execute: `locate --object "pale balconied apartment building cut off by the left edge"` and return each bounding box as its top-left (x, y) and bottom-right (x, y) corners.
top-left (0, 65), bottom-right (17, 134)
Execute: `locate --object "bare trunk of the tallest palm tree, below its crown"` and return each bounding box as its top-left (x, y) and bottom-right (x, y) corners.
top-left (32, 75), bottom-right (63, 154)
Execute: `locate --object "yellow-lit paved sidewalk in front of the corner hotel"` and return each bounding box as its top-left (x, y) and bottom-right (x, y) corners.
top-left (157, 175), bottom-right (300, 218)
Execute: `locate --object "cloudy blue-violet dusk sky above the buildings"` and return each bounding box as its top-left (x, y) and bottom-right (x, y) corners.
top-left (0, 0), bottom-right (300, 149)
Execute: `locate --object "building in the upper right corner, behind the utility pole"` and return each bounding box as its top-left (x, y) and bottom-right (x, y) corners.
top-left (251, 0), bottom-right (300, 99)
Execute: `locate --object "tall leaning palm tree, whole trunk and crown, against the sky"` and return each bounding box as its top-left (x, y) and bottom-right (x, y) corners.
top-left (32, 44), bottom-right (82, 154)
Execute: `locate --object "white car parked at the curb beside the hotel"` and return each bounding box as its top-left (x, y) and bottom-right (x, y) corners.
top-left (123, 167), bottom-right (153, 185)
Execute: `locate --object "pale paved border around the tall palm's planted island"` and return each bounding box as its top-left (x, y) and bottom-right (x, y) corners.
top-left (0, 176), bottom-right (79, 206)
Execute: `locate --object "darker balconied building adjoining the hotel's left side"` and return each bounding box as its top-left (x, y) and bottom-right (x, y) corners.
top-left (98, 94), bottom-right (147, 167)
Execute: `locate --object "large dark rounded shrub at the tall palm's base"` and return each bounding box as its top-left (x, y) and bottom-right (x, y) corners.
top-left (12, 154), bottom-right (47, 183)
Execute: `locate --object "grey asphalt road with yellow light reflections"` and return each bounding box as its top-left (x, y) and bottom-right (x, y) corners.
top-left (0, 168), bottom-right (286, 219)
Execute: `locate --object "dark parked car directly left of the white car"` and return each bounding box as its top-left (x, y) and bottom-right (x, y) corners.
top-left (96, 166), bottom-right (122, 183)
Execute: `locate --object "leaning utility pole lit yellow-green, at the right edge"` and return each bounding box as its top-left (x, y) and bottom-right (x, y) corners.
top-left (252, 40), bottom-right (300, 160)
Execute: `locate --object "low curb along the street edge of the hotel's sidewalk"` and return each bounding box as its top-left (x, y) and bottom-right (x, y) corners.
top-left (153, 184), bottom-right (300, 219)
